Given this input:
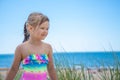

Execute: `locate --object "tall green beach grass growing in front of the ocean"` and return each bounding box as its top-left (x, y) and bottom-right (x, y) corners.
top-left (0, 53), bottom-right (120, 80)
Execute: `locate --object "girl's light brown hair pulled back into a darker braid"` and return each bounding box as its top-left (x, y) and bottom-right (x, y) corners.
top-left (23, 12), bottom-right (49, 42)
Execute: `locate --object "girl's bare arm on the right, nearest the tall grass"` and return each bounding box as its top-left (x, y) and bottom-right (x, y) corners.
top-left (48, 46), bottom-right (58, 80)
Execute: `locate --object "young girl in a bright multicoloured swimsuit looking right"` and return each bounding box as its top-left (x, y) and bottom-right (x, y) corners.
top-left (6, 12), bottom-right (57, 80)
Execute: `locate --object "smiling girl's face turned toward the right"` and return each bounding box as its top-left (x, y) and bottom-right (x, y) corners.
top-left (32, 21), bottom-right (49, 40)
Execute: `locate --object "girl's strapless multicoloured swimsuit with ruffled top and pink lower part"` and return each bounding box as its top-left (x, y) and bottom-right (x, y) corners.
top-left (20, 54), bottom-right (48, 80)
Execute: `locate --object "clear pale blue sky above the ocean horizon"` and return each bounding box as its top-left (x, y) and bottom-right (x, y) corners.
top-left (0, 0), bottom-right (120, 53)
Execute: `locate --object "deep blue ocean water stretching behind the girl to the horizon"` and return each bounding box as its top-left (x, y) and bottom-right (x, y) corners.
top-left (0, 52), bottom-right (120, 68)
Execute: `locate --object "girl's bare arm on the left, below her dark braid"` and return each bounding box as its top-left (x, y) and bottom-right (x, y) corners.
top-left (5, 46), bottom-right (21, 80)
